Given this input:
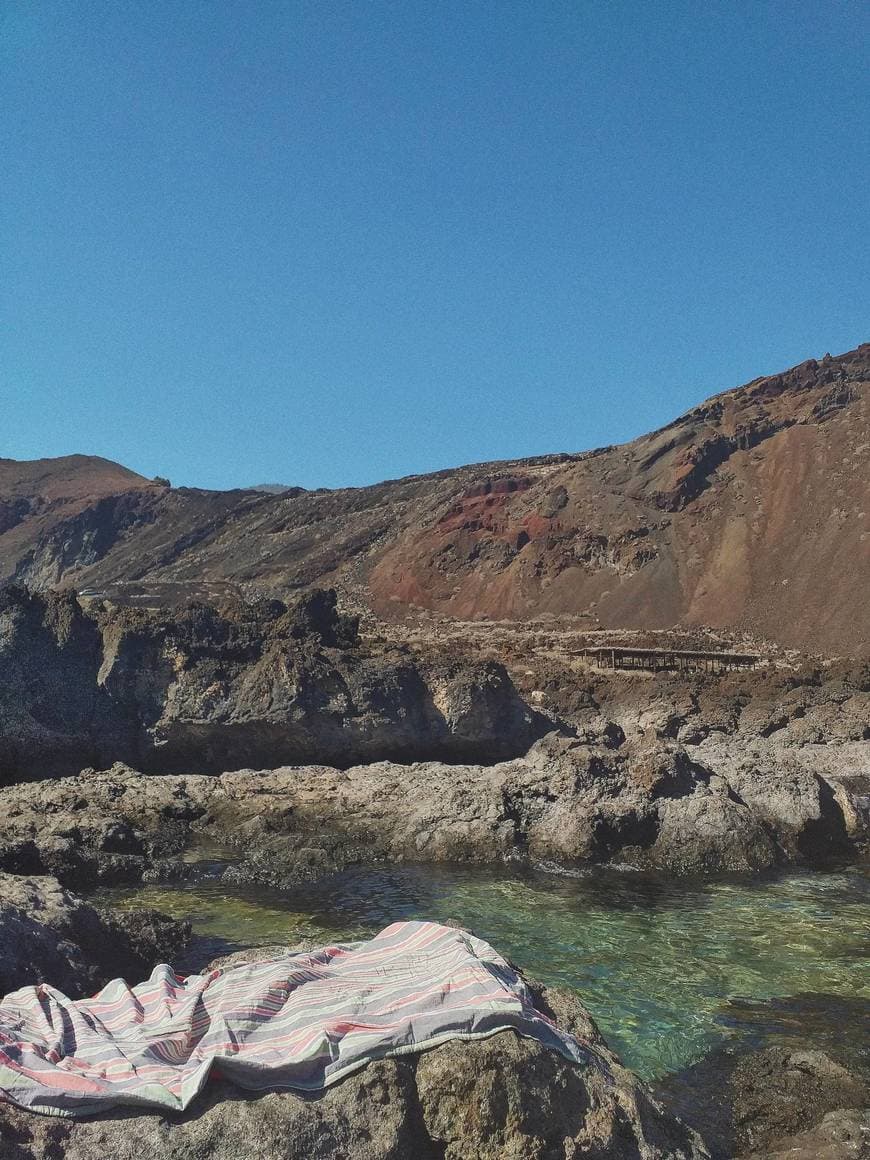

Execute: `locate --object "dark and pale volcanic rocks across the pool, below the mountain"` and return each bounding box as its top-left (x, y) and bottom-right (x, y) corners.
top-left (0, 590), bottom-right (870, 886)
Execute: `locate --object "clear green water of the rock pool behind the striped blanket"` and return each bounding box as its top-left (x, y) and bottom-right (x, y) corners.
top-left (100, 867), bottom-right (870, 1079)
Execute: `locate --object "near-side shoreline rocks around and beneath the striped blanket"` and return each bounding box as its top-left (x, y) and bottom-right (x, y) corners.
top-left (0, 875), bottom-right (870, 1160)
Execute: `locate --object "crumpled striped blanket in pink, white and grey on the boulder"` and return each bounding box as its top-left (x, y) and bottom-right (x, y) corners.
top-left (0, 922), bottom-right (588, 1116)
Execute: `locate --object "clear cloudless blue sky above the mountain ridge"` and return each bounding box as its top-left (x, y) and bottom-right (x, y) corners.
top-left (0, 0), bottom-right (870, 487)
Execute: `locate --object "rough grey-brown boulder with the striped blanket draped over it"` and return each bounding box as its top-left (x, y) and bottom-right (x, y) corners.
top-left (0, 989), bottom-right (708, 1160)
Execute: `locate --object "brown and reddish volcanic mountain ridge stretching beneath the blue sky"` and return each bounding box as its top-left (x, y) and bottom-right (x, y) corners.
top-left (0, 343), bottom-right (870, 655)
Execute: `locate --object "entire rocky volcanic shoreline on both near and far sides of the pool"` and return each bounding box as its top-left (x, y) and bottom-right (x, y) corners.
top-left (0, 589), bottom-right (870, 1160)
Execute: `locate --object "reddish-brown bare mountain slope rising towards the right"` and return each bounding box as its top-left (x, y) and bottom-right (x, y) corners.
top-left (370, 346), bottom-right (870, 650)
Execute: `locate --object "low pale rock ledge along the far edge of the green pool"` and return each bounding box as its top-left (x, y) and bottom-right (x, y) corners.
top-left (0, 720), bottom-right (861, 887)
